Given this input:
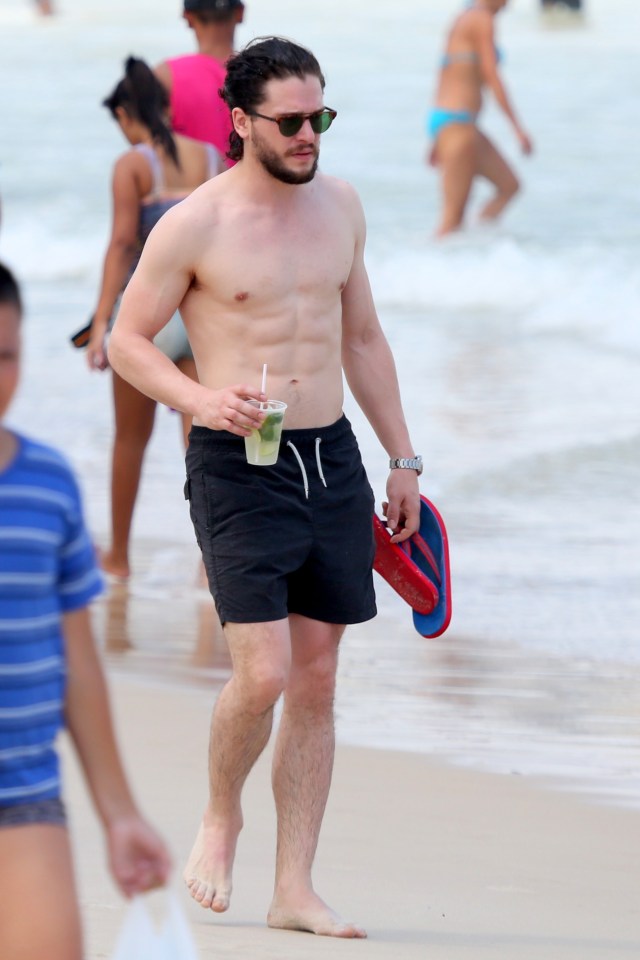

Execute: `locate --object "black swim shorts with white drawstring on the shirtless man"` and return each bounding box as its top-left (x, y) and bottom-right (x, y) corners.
top-left (185, 416), bottom-right (376, 624)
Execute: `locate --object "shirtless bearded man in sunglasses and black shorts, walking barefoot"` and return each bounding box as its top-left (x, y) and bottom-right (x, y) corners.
top-left (109, 38), bottom-right (421, 937)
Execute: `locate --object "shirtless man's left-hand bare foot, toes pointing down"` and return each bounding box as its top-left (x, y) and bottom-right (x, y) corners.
top-left (182, 813), bottom-right (242, 913)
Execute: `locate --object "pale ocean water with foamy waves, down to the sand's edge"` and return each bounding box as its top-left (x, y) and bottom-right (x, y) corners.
top-left (0, 0), bottom-right (640, 805)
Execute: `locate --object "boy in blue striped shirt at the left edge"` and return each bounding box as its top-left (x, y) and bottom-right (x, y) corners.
top-left (0, 264), bottom-right (170, 960)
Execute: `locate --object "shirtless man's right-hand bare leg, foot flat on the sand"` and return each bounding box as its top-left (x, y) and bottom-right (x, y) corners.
top-left (268, 615), bottom-right (366, 937)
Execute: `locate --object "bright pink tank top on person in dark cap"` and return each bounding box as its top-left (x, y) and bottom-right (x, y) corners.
top-left (167, 53), bottom-right (231, 156)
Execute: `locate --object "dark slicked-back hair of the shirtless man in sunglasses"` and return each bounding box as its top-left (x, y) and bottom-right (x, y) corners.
top-left (220, 37), bottom-right (324, 160)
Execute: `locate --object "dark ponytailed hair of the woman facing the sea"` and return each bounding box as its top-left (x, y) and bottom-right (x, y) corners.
top-left (102, 57), bottom-right (180, 167)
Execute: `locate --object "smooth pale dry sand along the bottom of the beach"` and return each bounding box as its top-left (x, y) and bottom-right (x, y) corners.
top-left (63, 625), bottom-right (640, 960)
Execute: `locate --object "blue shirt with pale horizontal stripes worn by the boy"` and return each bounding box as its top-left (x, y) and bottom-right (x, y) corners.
top-left (0, 435), bottom-right (102, 806)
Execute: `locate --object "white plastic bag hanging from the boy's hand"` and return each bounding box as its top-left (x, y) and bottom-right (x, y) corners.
top-left (111, 891), bottom-right (198, 960)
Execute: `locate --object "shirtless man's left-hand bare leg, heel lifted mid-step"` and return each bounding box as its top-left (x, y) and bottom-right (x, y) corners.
top-left (183, 620), bottom-right (291, 913)
